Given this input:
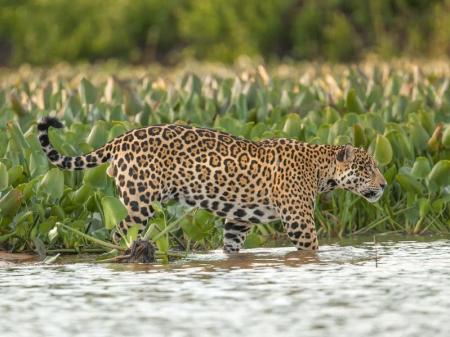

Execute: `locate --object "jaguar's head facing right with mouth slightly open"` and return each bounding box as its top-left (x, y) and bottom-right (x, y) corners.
top-left (334, 145), bottom-right (387, 202)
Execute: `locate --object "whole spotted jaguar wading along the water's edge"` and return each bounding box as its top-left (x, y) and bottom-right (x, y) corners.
top-left (38, 117), bottom-right (386, 253)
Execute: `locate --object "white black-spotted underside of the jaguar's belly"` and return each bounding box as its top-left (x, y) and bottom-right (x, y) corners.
top-left (179, 198), bottom-right (279, 223)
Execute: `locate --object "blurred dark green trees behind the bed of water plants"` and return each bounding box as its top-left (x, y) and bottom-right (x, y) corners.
top-left (0, 0), bottom-right (450, 66)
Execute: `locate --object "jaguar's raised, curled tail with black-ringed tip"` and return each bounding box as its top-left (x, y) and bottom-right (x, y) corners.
top-left (37, 117), bottom-right (111, 170)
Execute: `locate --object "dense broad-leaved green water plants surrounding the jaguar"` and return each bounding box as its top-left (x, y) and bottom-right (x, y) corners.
top-left (0, 64), bottom-right (450, 255)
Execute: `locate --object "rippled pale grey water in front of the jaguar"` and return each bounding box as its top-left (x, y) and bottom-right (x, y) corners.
top-left (0, 237), bottom-right (450, 337)
